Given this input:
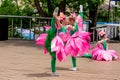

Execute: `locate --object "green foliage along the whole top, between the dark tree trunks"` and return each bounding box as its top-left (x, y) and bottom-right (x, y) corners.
top-left (0, 0), bottom-right (104, 18)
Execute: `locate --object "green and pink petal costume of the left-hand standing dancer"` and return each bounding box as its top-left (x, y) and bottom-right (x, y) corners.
top-left (36, 7), bottom-right (66, 73)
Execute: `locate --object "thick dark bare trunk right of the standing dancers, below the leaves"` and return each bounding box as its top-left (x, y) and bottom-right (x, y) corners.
top-left (89, 7), bottom-right (98, 41)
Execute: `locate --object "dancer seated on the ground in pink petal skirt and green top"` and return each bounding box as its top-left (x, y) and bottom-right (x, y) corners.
top-left (92, 31), bottom-right (118, 61)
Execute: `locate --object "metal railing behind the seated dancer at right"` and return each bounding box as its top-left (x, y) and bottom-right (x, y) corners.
top-left (91, 25), bottom-right (120, 42)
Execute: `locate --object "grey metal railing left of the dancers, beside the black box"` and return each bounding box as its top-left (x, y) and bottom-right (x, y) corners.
top-left (0, 15), bottom-right (51, 40)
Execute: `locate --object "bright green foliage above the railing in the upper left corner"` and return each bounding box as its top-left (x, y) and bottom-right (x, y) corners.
top-left (0, 0), bottom-right (34, 16)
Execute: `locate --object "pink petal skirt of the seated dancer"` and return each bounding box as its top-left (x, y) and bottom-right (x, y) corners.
top-left (92, 44), bottom-right (118, 61)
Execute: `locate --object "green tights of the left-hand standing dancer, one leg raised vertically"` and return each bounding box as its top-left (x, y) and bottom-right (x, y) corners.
top-left (45, 18), bottom-right (56, 72)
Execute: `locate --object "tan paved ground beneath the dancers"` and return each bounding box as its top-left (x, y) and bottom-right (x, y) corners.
top-left (0, 40), bottom-right (120, 80)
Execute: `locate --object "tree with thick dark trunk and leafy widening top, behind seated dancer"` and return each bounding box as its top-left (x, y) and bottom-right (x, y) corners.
top-left (87, 0), bottom-right (105, 39)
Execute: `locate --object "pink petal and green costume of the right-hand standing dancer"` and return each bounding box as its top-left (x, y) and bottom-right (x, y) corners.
top-left (65, 11), bottom-right (90, 68)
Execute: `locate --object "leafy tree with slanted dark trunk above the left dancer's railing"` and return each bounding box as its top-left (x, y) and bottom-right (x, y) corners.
top-left (34, 0), bottom-right (60, 17)
